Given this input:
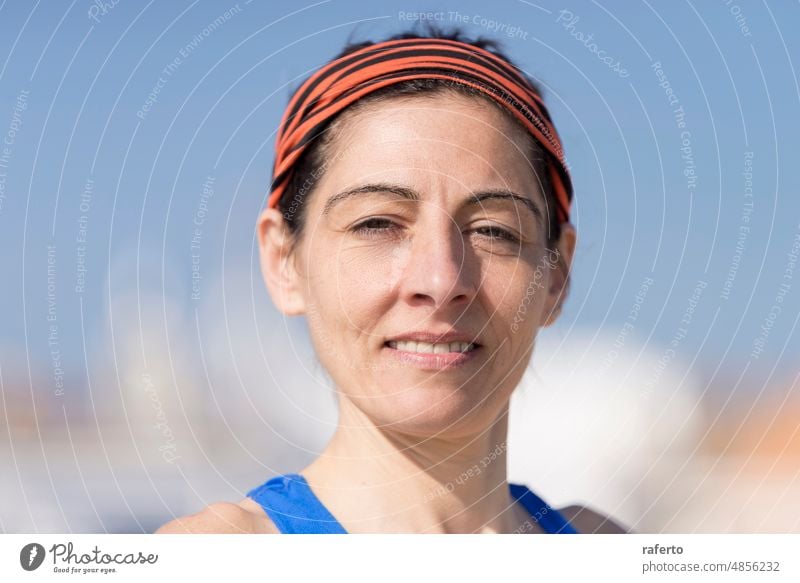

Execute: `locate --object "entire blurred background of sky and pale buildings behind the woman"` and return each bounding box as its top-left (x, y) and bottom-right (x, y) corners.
top-left (0, 0), bottom-right (800, 533)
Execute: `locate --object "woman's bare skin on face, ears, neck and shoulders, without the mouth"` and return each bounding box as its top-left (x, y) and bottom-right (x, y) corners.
top-left (158, 92), bottom-right (623, 533)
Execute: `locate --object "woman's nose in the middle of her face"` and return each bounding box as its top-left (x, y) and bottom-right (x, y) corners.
top-left (401, 213), bottom-right (477, 310)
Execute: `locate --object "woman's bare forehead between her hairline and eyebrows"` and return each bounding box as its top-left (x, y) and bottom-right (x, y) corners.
top-left (318, 95), bottom-right (534, 188)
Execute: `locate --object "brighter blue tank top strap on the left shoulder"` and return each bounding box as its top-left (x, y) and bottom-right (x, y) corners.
top-left (247, 474), bottom-right (347, 534)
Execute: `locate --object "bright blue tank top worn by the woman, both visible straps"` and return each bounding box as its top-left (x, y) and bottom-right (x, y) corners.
top-left (247, 474), bottom-right (578, 534)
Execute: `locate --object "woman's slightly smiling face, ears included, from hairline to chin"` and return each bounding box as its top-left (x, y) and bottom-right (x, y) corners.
top-left (260, 92), bottom-right (574, 436)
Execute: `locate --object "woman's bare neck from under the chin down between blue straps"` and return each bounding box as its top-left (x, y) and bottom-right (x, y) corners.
top-left (301, 399), bottom-right (530, 533)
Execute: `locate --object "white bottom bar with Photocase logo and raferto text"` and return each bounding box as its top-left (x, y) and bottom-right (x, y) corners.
top-left (0, 534), bottom-right (800, 583)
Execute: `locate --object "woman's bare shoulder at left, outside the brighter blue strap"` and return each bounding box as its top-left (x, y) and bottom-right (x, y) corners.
top-left (155, 498), bottom-right (278, 534)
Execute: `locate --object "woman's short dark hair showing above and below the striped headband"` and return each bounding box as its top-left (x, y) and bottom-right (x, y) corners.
top-left (278, 25), bottom-right (561, 247)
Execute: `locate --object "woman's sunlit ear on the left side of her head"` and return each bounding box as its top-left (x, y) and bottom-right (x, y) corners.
top-left (257, 208), bottom-right (306, 316)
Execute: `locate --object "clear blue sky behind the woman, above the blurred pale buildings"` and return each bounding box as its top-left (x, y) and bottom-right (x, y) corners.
top-left (0, 0), bottom-right (800, 402)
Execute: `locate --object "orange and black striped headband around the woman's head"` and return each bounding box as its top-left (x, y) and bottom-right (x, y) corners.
top-left (267, 38), bottom-right (572, 223)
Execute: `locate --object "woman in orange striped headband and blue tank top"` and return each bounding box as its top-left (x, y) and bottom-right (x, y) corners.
top-left (158, 33), bottom-right (622, 533)
